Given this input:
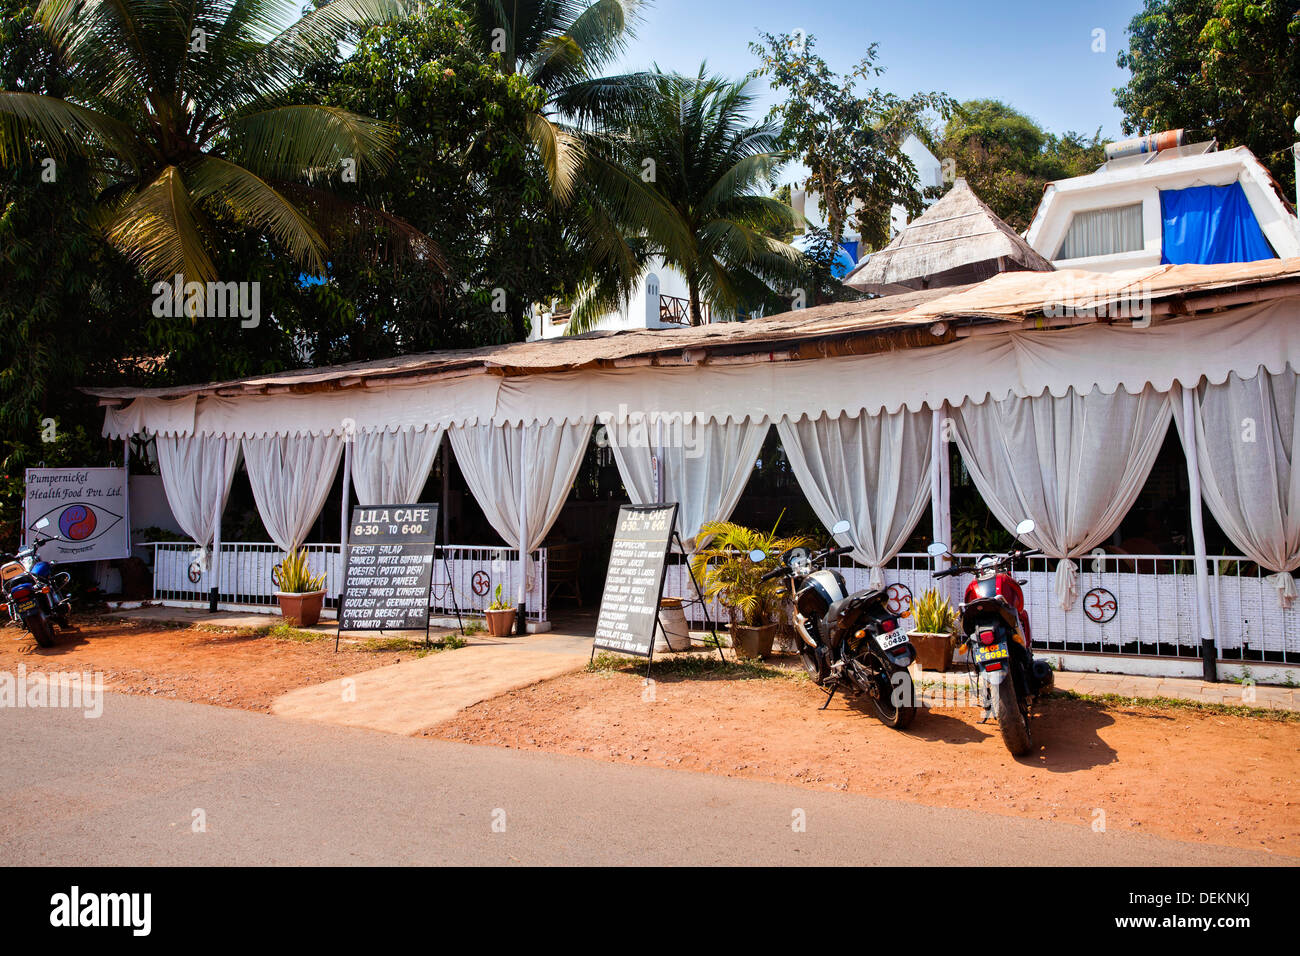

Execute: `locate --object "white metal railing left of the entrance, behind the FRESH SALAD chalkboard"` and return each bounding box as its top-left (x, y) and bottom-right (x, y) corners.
top-left (153, 541), bottom-right (547, 620)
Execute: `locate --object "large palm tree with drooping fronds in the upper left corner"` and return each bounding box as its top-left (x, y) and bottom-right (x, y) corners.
top-left (0, 0), bottom-right (438, 282)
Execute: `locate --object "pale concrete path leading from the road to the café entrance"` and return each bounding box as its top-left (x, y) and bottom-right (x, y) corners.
top-left (272, 632), bottom-right (592, 734)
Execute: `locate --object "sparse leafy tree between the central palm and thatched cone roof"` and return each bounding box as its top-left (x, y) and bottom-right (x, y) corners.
top-left (749, 33), bottom-right (952, 248)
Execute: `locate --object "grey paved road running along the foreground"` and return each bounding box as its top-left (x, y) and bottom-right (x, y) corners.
top-left (0, 695), bottom-right (1284, 865)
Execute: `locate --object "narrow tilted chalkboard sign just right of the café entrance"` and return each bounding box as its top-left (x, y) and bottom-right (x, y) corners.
top-left (595, 502), bottom-right (677, 657)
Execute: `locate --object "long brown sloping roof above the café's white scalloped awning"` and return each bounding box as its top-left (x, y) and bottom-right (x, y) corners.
top-left (81, 259), bottom-right (1300, 403)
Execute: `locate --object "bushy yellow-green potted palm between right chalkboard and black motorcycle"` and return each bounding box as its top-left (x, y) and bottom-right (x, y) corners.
top-left (690, 522), bottom-right (809, 658)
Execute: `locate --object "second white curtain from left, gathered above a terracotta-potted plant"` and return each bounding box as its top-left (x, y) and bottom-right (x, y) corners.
top-left (243, 434), bottom-right (343, 553)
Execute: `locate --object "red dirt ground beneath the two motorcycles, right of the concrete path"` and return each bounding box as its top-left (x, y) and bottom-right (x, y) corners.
top-left (425, 658), bottom-right (1300, 856)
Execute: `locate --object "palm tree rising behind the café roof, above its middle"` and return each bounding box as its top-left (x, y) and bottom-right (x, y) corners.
top-left (569, 66), bottom-right (806, 332)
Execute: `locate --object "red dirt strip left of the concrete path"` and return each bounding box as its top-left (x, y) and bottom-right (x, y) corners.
top-left (0, 618), bottom-right (428, 713)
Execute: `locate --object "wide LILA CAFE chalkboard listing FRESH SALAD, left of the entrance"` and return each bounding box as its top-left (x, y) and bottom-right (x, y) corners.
top-left (338, 505), bottom-right (438, 631)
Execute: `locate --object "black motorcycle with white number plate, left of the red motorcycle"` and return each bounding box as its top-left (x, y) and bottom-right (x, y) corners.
top-left (749, 522), bottom-right (917, 730)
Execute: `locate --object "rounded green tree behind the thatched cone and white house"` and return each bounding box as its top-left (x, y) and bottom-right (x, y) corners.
top-left (928, 100), bottom-right (1105, 232)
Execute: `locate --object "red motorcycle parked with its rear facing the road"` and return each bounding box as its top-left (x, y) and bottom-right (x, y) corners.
top-left (928, 518), bottom-right (1052, 757)
